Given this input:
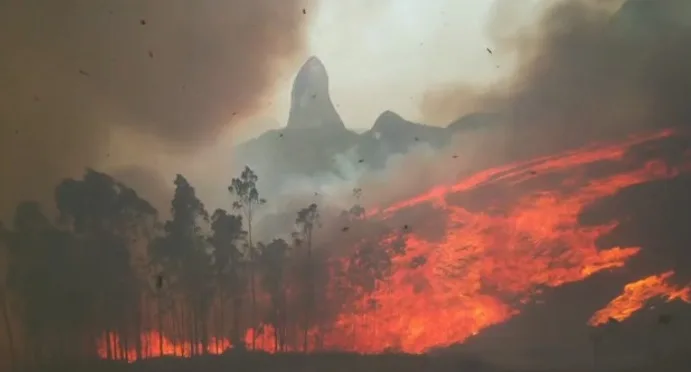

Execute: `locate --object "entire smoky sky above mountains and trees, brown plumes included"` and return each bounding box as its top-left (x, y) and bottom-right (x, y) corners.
top-left (0, 0), bottom-right (691, 219)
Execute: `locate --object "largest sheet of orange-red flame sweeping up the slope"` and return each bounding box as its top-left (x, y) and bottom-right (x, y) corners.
top-left (324, 132), bottom-right (676, 353)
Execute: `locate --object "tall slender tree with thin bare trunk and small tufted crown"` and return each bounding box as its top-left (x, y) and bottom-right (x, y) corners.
top-left (228, 166), bottom-right (266, 350)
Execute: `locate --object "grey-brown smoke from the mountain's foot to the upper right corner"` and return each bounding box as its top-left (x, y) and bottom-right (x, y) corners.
top-left (228, 0), bottom-right (691, 241)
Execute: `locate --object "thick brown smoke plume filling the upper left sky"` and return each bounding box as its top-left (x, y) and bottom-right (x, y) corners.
top-left (0, 0), bottom-right (312, 217)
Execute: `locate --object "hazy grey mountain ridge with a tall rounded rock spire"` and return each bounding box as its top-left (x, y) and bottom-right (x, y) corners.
top-left (233, 57), bottom-right (500, 192)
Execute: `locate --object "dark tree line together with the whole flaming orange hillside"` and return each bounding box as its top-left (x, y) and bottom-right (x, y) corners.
top-left (2, 130), bottom-right (691, 361)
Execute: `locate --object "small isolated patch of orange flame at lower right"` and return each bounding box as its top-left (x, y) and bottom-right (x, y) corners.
top-left (588, 271), bottom-right (691, 326)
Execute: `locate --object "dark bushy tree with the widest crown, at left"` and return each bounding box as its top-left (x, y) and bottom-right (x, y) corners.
top-left (55, 169), bottom-right (157, 358)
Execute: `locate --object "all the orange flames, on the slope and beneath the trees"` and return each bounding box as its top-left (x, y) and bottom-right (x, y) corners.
top-left (99, 131), bottom-right (690, 359)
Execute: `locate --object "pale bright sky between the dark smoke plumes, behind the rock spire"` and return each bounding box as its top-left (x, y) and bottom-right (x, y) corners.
top-left (142, 0), bottom-right (548, 209)
